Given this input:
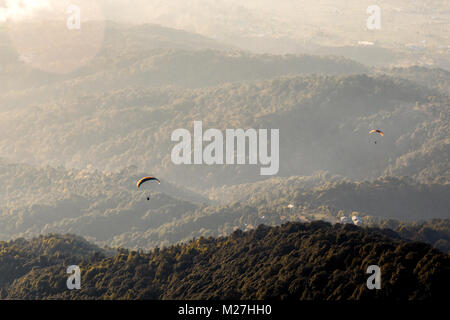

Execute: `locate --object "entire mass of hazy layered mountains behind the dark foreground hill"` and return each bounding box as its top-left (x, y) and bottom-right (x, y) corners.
top-left (0, 23), bottom-right (450, 255)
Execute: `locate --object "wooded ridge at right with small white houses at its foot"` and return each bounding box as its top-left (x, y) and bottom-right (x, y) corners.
top-left (210, 173), bottom-right (450, 221)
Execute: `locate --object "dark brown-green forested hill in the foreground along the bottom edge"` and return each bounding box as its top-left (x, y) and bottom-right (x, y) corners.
top-left (0, 222), bottom-right (450, 300)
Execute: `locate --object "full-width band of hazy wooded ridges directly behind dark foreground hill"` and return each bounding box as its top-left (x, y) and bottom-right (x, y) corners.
top-left (0, 161), bottom-right (450, 250)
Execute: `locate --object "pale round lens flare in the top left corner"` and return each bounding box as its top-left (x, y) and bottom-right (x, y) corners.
top-left (4, 0), bottom-right (105, 74)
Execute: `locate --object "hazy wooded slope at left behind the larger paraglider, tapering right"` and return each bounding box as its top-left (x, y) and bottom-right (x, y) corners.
top-left (0, 161), bottom-right (210, 247)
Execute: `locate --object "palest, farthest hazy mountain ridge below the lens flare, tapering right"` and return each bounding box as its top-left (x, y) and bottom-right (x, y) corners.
top-left (0, 22), bottom-right (367, 94)
